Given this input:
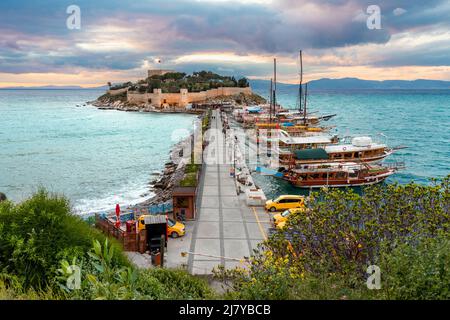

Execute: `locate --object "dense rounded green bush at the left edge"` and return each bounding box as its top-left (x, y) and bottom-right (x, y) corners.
top-left (0, 189), bottom-right (128, 289)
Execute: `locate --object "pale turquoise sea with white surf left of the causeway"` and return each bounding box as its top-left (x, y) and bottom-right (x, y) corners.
top-left (0, 90), bottom-right (195, 212)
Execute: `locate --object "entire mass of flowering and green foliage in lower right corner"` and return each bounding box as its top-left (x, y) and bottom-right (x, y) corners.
top-left (217, 177), bottom-right (450, 299)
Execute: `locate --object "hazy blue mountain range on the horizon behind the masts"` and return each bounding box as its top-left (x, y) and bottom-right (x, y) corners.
top-left (250, 78), bottom-right (450, 92)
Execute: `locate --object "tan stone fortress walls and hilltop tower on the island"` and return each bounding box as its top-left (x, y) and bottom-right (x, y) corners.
top-left (108, 70), bottom-right (252, 109)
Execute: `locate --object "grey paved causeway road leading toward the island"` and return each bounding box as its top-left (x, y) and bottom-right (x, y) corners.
top-left (186, 111), bottom-right (270, 274)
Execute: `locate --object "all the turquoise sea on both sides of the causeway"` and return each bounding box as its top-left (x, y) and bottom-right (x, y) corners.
top-left (0, 90), bottom-right (450, 212)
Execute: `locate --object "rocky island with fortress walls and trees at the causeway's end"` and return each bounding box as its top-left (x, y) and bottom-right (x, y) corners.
top-left (90, 70), bottom-right (266, 112)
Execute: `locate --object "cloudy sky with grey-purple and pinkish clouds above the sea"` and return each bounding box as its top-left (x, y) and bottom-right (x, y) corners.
top-left (0, 0), bottom-right (450, 87)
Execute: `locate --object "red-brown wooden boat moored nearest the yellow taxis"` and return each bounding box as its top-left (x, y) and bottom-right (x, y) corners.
top-left (283, 162), bottom-right (399, 188)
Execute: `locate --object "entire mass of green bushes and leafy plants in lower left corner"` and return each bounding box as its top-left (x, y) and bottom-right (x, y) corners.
top-left (0, 190), bottom-right (213, 299)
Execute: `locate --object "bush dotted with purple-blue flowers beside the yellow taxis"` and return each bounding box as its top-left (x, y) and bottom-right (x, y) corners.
top-left (280, 177), bottom-right (450, 274)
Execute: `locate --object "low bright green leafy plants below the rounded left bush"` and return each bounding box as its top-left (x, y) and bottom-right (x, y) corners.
top-left (58, 241), bottom-right (213, 300)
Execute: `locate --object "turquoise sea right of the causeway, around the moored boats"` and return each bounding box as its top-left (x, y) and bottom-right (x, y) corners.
top-left (254, 88), bottom-right (450, 198)
